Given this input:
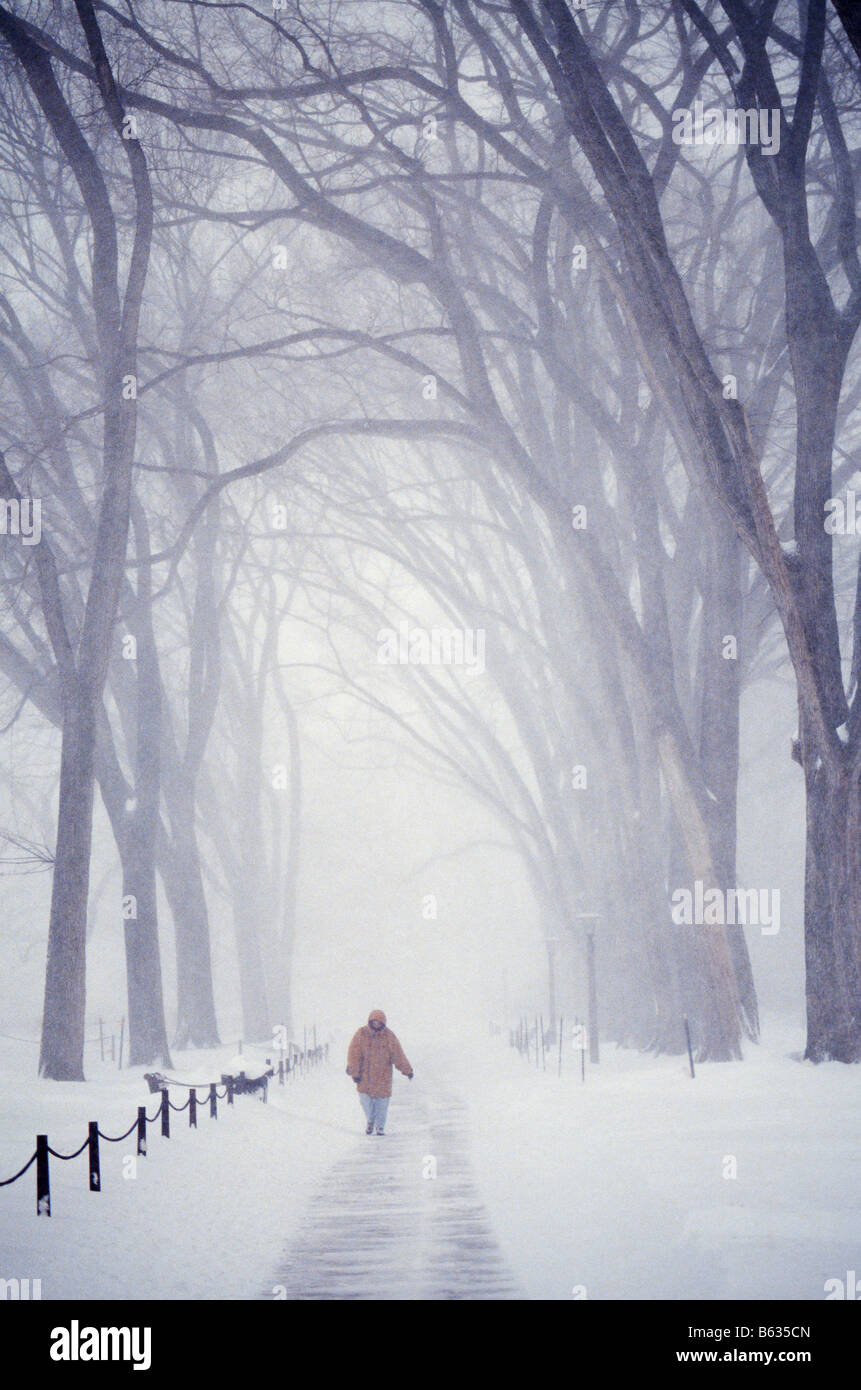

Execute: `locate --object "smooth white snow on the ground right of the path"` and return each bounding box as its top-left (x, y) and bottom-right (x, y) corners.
top-left (459, 1024), bottom-right (861, 1300)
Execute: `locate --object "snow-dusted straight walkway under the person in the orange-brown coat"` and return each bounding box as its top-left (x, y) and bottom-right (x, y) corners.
top-left (266, 1077), bottom-right (523, 1300)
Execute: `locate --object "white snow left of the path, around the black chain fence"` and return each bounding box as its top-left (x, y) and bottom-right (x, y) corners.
top-left (0, 1043), bottom-right (362, 1298)
